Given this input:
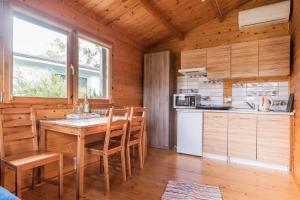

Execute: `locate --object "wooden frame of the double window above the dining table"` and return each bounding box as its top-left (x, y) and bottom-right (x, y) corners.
top-left (0, 3), bottom-right (113, 105)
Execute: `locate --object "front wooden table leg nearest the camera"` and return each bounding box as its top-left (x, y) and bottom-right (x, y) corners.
top-left (76, 130), bottom-right (85, 199)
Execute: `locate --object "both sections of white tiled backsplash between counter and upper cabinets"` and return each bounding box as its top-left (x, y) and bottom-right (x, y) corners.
top-left (177, 76), bottom-right (289, 111)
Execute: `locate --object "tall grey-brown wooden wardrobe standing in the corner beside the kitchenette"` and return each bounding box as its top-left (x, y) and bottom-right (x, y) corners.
top-left (144, 51), bottom-right (171, 148)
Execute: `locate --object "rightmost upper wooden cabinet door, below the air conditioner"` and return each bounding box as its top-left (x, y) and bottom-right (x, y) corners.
top-left (259, 36), bottom-right (290, 76)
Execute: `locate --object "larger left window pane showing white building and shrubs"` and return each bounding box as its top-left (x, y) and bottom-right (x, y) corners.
top-left (13, 14), bottom-right (67, 98)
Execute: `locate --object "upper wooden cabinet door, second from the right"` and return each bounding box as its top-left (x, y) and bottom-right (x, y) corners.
top-left (231, 41), bottom-right (258, 78)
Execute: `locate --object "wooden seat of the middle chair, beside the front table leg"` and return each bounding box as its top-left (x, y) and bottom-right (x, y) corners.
top-left (85, 140), bottom-right (122, 155)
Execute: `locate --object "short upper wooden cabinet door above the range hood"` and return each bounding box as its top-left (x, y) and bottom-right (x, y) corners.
top-left (181, 49), bottom-right (207, 68)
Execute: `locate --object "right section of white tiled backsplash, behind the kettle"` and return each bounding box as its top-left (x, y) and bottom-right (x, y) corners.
top-left (232, 82), bottom-right (289, 111)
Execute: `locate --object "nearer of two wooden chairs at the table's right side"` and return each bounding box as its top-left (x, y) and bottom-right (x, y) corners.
top-left (86, 108), bottom-right (129, 192)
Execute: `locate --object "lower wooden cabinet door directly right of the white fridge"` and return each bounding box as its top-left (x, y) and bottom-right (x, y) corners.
top-left (203, 112), bottom-right (228, 156)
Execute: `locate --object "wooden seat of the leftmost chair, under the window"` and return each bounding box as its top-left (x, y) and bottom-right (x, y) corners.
top-left (1, 151), bottom-right (60, 170)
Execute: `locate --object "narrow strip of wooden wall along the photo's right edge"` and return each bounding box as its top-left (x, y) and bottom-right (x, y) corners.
top-left (291, 0), bottom-right (300, 186)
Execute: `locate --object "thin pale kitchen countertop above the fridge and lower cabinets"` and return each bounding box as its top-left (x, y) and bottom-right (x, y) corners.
top-left (176, 108), bottom-right (295, 116)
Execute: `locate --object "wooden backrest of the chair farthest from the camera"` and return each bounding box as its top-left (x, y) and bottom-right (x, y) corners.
top-left (127, 107), bottom-right (146, 141)
